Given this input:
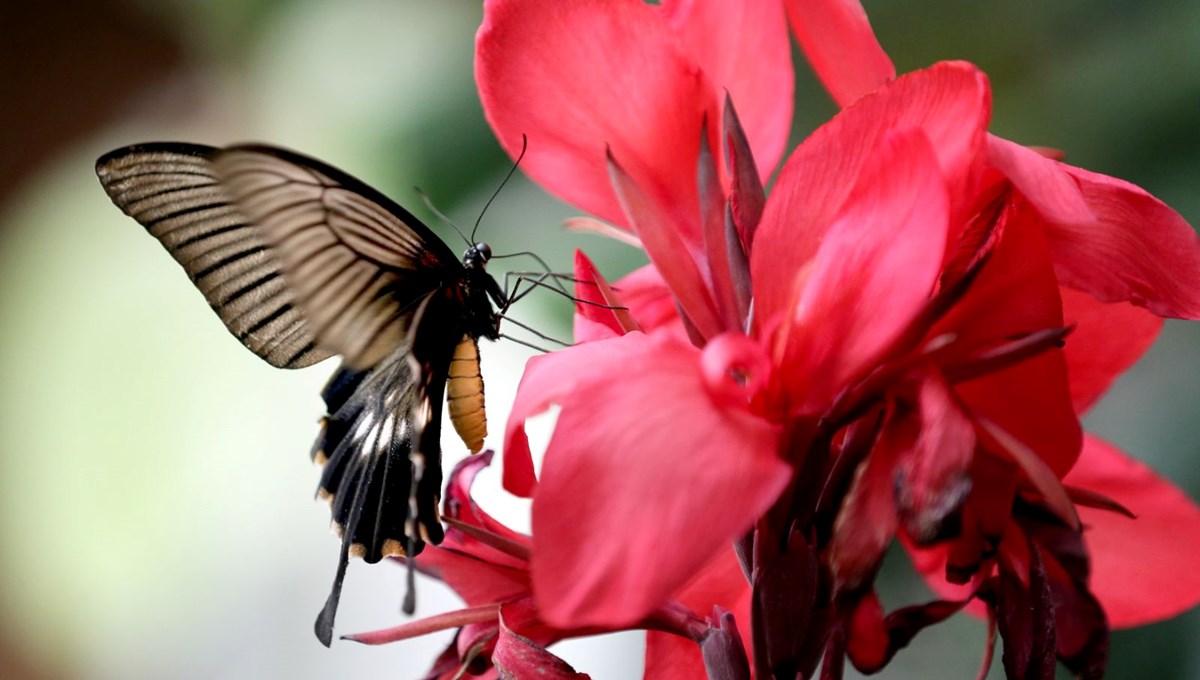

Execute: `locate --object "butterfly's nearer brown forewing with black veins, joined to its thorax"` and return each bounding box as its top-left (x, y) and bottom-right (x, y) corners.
top-left (214, 146), bottom-right (464, 368)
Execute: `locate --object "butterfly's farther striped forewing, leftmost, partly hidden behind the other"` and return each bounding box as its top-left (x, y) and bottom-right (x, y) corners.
top-left (96, 143), bottom-right (331, 368)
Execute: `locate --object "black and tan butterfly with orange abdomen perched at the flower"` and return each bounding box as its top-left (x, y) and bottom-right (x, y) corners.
top-left (96, 143), bottom-right (509, 646)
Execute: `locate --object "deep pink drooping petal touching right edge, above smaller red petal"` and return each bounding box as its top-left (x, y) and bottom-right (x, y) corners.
top-left (1046, 166), bottom-right (1200, 319)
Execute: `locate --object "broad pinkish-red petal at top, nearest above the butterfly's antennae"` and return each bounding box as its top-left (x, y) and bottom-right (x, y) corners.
top-left (475, 0), bottom-right (720, 239)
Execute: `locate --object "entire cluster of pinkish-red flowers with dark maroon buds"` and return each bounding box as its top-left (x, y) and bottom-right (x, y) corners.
top-left (358, 0), bottom-right (1200, 679)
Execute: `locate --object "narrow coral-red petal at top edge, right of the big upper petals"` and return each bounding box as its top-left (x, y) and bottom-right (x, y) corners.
top-left (787, 0), bottom-right (896, 107)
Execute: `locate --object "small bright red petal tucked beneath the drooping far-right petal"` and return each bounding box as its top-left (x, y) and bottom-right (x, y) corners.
top-left (1061, 288), bottom-right (1163, 414)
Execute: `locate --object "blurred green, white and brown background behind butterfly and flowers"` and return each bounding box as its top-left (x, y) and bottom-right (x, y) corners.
top-left (0, 0), bottom-right (1200, 680)
